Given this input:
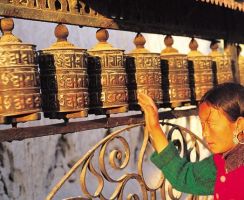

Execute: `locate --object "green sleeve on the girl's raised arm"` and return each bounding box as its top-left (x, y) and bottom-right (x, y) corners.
top-left (151, 142), bottom-right (216, 195)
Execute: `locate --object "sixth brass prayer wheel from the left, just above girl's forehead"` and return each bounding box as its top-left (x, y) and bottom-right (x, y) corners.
top-left (188, 38), bottom-right (214, 102)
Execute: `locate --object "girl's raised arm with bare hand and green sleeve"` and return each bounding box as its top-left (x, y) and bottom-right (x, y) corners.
top-left (138, 93), bottom-right (216, 195)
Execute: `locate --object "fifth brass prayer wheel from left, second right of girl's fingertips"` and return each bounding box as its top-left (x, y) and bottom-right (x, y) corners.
top-left (160, 35), bottom-right (191, 107)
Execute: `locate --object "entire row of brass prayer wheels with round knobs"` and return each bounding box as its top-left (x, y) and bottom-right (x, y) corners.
top-left (0, 18), bottom-right (240, 124)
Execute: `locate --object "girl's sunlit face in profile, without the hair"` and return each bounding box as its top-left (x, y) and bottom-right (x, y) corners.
top-left (199, 102), bottom-right (235, 153)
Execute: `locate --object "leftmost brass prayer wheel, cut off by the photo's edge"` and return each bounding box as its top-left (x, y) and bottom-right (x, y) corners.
top-left (0, 18), bottom-right (41, 124)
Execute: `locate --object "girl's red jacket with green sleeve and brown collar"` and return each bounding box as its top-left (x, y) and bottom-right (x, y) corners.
top-left (151, 142), bottom-right (244, 200)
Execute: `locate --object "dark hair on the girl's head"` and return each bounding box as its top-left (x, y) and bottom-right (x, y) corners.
top-left (200, 83), bottom-right (244, 121)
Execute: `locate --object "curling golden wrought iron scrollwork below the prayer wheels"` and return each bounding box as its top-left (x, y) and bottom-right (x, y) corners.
top-left (46, 122), bottom-right (212, 200)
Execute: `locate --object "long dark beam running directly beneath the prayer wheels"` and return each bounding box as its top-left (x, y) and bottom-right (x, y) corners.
top-left (0, 108), bottom-right (197, 142)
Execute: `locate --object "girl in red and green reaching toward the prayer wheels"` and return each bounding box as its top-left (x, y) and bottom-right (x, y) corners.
top-left (138, 83), bottom-right (244, 200)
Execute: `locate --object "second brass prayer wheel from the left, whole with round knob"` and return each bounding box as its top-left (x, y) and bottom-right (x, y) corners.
top-left (39, 24), bottom-right (88, 119)
